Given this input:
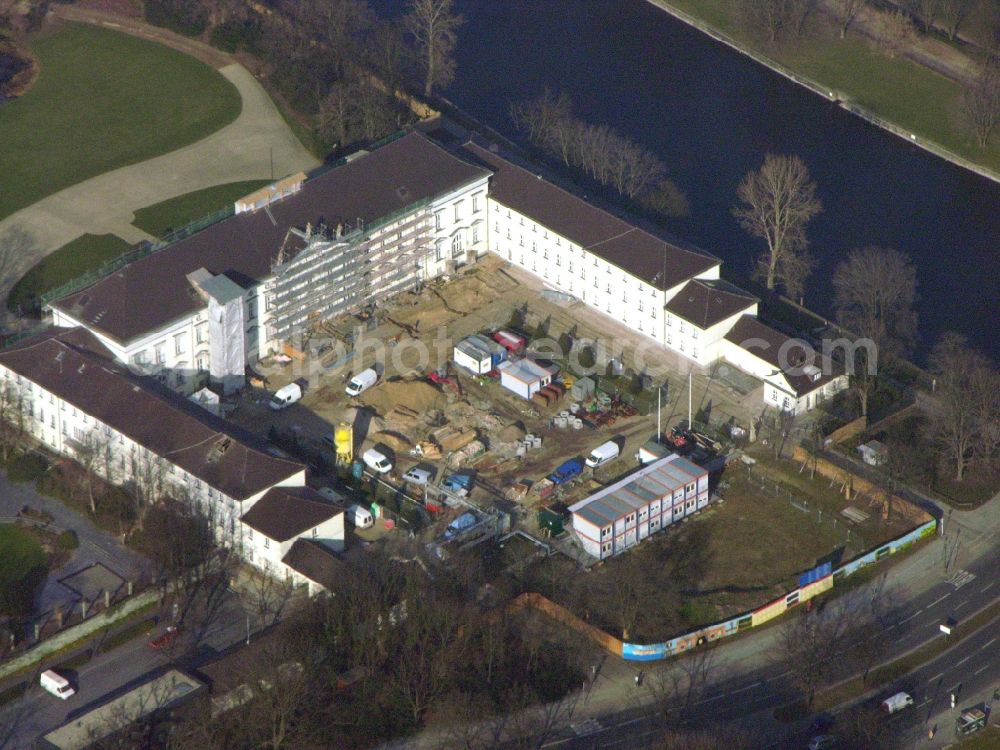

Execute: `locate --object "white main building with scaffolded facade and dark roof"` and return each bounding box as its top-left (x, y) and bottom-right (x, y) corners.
top-left (51, 133), bottom-right (489, 393)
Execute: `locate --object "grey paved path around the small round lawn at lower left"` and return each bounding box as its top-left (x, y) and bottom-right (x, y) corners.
top-left (0, 474), bottom-right (151, 612)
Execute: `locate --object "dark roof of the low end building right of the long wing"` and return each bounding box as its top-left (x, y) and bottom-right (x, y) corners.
top-left (726, 315), bottom-right (844, 396)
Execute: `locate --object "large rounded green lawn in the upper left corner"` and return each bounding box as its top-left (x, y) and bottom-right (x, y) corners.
top-left (0, 24), bottom-right (241, 223)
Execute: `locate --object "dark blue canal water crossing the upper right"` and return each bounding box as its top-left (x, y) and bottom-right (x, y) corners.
top-left (380, 0), bottom-right (1000, 360)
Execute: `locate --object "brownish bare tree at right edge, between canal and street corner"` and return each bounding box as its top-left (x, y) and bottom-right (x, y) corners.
top-left (929, 333), bottom-right (990, 482)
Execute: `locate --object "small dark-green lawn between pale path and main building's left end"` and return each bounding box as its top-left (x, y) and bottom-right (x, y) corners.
top-left (7, 234), bottom-right (131, 312)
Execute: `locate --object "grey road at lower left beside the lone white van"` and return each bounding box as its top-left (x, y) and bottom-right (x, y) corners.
top-left (0, 592), bottom-right (247, 750)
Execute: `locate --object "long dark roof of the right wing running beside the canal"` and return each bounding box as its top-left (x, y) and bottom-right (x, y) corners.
top-left (464, 142), bottom-right (719, 289)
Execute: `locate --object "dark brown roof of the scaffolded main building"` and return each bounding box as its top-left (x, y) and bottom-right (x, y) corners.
top-left (52, 133), bottom-right (488, 343)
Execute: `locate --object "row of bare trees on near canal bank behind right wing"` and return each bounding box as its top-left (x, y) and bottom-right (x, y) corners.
top-left (511, 89), bottom-right (689, 217)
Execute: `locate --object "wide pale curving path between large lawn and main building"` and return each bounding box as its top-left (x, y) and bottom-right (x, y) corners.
top-left (0, 36), bottom-right (318, 293)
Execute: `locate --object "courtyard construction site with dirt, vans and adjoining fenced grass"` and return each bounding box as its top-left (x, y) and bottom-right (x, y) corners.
top-left (219, 256), bottom-right (928, 632)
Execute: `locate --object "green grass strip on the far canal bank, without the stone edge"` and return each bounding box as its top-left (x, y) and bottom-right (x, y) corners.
top-left (658, 0), bottom-right (1000, 171)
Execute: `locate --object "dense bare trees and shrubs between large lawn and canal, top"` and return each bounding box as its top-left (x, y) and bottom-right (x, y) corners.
top-left (144, 0), bottom-right (462, 154)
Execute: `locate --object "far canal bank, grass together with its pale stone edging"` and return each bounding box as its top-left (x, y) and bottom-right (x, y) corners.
top-left (646, 0), bottom-right (1000, 183)
